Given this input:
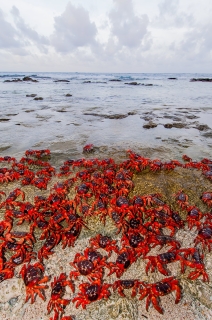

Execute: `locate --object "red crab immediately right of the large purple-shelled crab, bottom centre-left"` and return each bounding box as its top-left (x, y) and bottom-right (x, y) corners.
top-left (107, 248), bottom-right (136, 278)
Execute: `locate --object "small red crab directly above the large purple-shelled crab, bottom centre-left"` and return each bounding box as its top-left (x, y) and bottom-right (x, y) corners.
top-left (89, 234), bottom-right (119, 257)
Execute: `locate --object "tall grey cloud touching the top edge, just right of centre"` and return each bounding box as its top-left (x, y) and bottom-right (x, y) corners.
top-left (109, 0), bottom-right (149, 47)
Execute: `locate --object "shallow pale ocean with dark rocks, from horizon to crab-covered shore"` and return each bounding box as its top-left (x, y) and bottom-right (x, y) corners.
top-left (0, 72), bottom-right (212, 160)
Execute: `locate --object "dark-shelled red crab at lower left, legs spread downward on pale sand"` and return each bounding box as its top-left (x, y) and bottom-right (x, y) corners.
top-left (20, 262), bottom-right (49, 303)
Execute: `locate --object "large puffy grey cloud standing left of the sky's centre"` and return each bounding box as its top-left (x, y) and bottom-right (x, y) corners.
top-left (51, 2), bottom-right (97, 53)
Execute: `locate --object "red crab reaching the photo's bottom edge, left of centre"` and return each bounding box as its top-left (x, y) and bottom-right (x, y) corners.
top-left (47, 273), bottom-right (75, 320)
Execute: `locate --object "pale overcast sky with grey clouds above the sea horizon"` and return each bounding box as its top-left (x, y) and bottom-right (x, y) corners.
top-left (0, 0), bottom-right (212, 73)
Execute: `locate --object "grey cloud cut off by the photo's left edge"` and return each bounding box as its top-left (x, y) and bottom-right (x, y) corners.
top-left (0, 9), bottom-right (21, 49)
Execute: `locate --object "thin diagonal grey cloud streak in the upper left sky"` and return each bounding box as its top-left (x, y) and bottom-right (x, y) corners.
top-left (11, 6), bottom-right (49, 53)
